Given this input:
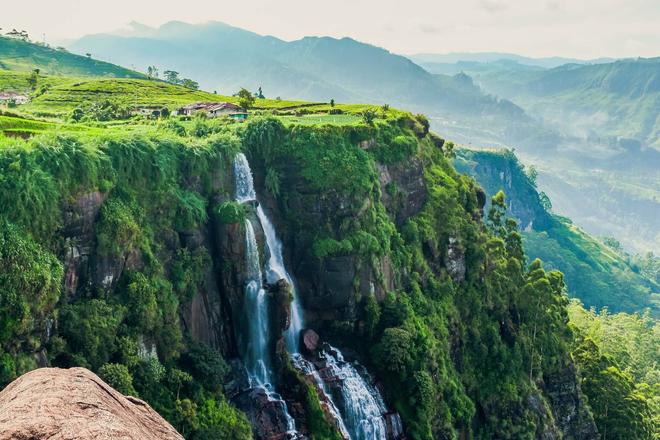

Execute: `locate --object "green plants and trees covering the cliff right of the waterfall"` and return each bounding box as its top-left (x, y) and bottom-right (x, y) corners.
top-left (243, 116), bottom-right (588, 439)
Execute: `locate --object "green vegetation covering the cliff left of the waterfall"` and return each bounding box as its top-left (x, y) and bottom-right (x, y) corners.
top-left (0, 127), bottom-right (251, 439)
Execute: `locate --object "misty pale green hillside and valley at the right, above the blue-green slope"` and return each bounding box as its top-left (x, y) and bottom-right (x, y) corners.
top-left (474, 58), bottom-right (660, 252)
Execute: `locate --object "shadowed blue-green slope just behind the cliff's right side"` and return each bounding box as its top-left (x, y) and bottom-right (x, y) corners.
top-left (457, 150), bottom-right (660, 317)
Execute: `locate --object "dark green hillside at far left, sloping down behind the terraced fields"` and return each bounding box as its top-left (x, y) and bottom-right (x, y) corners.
top-left (0, 36), bottom-right (144, 78)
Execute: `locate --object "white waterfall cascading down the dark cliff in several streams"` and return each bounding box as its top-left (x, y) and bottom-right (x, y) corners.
top-left (234, 153), bottom-right (394, 440)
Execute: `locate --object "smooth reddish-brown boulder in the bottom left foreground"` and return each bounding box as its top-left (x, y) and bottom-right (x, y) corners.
top-left (0, 368), bottom-right (183, 440)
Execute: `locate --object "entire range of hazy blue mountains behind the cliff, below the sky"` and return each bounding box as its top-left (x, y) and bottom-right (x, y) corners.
top-left (69, 22), bottom-right (660, 251)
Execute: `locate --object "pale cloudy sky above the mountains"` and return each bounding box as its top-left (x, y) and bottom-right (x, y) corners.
top-left (0, 0), bottom-right (660, 59)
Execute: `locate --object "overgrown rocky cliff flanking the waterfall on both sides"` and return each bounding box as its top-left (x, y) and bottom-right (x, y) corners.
top-left (0, 102), bottom-right (597, 440)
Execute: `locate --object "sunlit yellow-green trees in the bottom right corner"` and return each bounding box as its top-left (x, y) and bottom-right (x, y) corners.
top-left (568, 301), bottom-right (660, 438)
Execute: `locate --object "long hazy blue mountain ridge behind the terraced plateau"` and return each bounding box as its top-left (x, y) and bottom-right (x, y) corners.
top-left (70, 22), bottom-right (526, 123)
